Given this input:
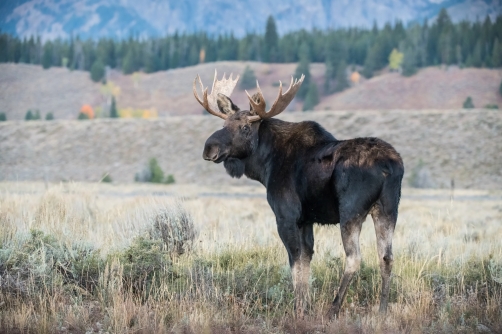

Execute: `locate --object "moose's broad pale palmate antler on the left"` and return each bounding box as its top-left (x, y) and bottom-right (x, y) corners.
top-left (193, 70), bottom-right (239, 119)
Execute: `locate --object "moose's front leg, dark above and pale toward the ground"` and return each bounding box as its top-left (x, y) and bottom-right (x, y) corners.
top-left (278, 222), bottom-right (314, 318)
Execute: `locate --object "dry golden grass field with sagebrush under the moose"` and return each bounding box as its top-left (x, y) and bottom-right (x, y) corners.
top-left (0, 182), bottom-right (502, 333)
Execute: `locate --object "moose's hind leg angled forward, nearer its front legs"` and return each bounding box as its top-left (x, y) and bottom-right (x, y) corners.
top-left (328, 216), bottom-right (365, 316)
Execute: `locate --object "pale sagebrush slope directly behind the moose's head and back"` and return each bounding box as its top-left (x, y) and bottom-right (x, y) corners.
top-left (0, 109), bottom-right (502, 189)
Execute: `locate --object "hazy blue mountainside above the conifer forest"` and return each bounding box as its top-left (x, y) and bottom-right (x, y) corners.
top-left (0, 0), bottom-right (502, 39)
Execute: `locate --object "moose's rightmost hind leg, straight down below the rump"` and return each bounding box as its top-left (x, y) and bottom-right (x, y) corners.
top-left (371, 204), bottom-right (397, 313)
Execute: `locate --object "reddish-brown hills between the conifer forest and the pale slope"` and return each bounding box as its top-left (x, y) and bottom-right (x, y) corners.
top-left (0, 62), bottom-right (502, 120)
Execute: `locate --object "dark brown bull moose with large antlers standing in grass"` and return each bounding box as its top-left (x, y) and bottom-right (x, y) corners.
top-left (193, 71), bottom-right (404, 317)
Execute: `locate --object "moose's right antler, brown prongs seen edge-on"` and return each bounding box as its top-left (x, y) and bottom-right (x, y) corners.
top-left (246, 74), bottom-right (305, 122)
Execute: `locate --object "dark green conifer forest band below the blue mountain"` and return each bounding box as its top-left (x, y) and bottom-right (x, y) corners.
top-left (0, 9), bottom-right (502, 83)
